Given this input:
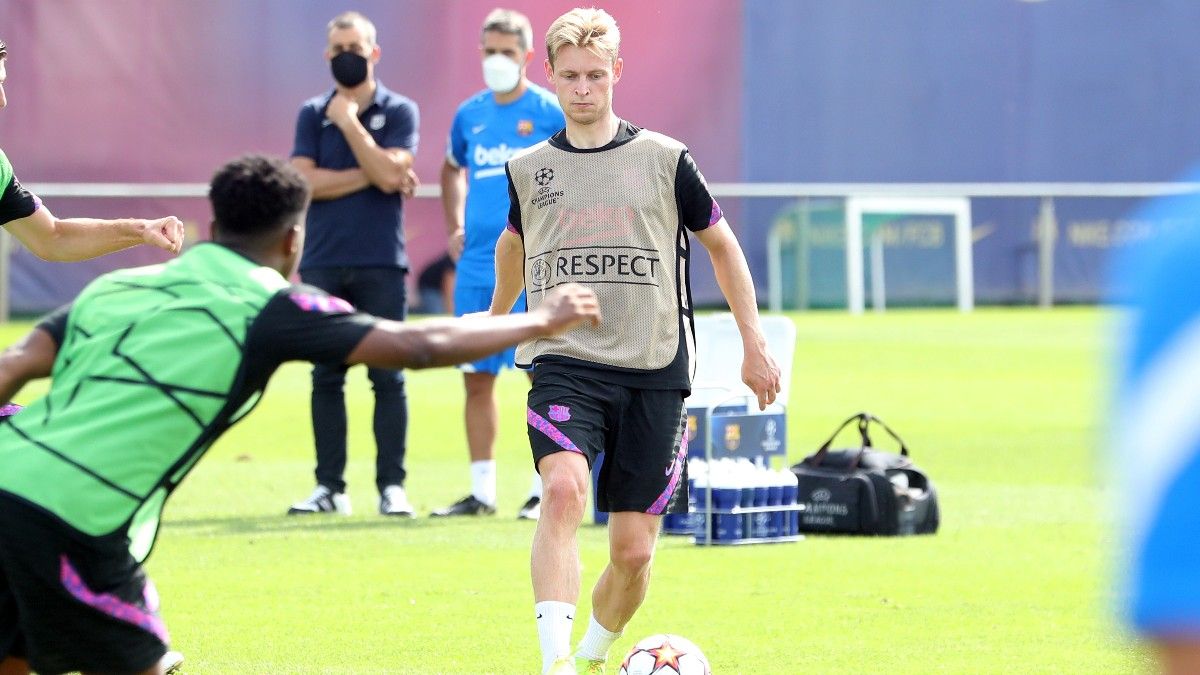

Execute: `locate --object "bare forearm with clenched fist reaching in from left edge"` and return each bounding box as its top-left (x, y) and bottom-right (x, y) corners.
top-left (5, 205), bottom-right (184, 262)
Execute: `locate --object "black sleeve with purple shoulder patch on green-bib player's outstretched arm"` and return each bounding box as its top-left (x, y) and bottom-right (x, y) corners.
top-left (246, 285), bottom-right (379, 364)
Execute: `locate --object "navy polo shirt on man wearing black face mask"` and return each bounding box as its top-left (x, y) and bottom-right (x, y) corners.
top-left (292, 82), bottom-right (419, 270)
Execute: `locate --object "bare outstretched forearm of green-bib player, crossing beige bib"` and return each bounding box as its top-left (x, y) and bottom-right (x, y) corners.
top-left (347, 283), bottom-right (600, 369)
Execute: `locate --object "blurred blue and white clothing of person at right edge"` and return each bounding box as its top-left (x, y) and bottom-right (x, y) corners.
top-left (1111, 170), bottom-right (1200, 637)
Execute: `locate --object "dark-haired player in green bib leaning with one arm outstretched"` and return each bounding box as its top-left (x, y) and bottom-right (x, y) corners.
top-left (0, 156), bottom-right (599, 675)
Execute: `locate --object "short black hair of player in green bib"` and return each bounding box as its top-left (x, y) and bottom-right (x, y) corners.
top-left (209, 155), bottom-right (311, 237)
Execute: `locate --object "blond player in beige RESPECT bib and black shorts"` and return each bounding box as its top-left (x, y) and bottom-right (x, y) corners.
top-left (491, 8), bottom-right (780, 675)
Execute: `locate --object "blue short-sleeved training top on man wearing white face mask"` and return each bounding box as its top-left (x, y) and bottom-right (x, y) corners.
top-left (446, 83), bottom-right (565, 288)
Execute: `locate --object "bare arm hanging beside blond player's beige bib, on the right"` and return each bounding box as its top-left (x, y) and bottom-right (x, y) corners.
top-left (696, 217), bottom-right (780, 410)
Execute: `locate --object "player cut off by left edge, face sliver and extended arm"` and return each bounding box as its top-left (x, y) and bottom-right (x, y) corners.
top-left (0, 40), bottom-right (184, 262)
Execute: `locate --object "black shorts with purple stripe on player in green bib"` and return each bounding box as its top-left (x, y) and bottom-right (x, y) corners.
top-left (0, 495), bottom-right (168, 675)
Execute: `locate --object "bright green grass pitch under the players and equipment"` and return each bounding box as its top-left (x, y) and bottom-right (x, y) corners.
top-left (0, 309), bottom-right (1150, 675)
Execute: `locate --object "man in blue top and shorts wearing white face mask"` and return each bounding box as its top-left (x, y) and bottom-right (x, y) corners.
top-left (432, 10), bottom-right (563, 520)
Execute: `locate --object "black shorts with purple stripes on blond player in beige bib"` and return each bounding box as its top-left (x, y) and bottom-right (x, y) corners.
top-left (528, 369), bottom-right (688, 515)
